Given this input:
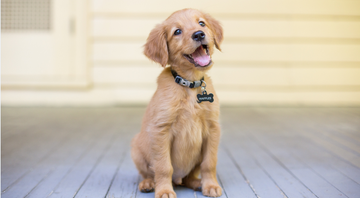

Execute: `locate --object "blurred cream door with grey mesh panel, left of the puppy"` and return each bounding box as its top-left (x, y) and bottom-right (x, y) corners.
top-left (1, 0), bottom-right (87, 89)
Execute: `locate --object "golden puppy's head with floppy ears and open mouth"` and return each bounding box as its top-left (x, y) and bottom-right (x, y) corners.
top-left (144, 9), bottom-right (223, 70)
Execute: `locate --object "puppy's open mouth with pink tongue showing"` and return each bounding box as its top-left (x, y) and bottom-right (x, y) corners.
top-left (184, 45), bottom-right (211, 67)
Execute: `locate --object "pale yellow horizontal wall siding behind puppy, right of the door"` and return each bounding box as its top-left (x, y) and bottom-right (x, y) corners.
top-left (91, 0), bottom-right (360, 104)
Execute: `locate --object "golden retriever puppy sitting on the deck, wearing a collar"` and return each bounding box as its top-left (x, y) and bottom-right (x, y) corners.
top-left (131, 9), bottom-right (223, 198)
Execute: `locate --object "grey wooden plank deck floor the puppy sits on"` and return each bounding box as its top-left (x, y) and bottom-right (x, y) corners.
top-left (1, 108), bottom-right (360, 198)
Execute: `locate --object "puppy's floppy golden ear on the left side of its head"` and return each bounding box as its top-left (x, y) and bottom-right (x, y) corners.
top-left (144, 24), bottom-right (169, 67)
